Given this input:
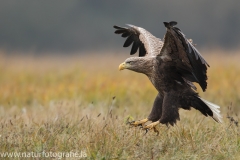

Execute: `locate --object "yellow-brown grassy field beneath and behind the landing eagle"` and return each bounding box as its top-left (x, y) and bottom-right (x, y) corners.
top-left (0, 51), bottom-right (240, 160)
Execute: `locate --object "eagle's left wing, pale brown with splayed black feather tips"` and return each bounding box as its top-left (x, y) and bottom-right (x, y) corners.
top-left (113, 25), bottom-right (163, 57)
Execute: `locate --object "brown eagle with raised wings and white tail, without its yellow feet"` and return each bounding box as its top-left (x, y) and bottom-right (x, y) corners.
top-left (114, 22), bottom-right (221, 125)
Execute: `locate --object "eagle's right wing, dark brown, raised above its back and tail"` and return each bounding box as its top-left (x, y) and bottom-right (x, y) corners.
top-left (158, 22), bottom-right (209, 91)
